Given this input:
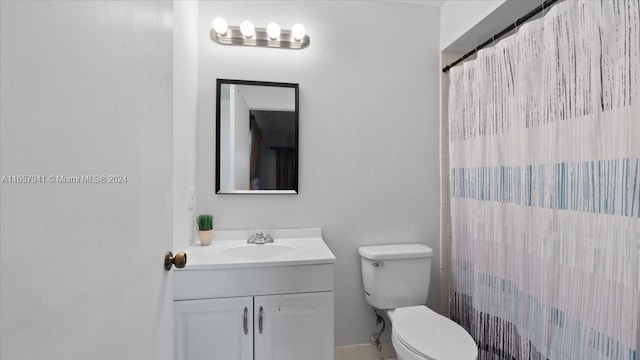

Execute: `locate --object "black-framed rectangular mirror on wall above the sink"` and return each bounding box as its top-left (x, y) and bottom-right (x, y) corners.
top-left (216, 79), bottom-right (299, 194)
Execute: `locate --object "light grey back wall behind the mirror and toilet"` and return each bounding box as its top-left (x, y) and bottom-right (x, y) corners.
top-left (197, 1), bottom-right (440, 346)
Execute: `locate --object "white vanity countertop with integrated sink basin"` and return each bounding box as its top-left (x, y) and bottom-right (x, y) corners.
top-left (176, 228), bottom-right (336, 271)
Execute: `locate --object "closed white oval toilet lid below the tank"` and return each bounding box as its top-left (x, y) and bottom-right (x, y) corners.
top-left (393, 306), bottom-right (478, 360)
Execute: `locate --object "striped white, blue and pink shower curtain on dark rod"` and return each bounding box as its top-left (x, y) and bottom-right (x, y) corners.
top-left (449, 0), bottom-right (640, 360)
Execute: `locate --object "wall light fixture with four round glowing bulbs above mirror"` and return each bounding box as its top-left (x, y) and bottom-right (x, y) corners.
top-left (211, 17), bottom-right (310, 50)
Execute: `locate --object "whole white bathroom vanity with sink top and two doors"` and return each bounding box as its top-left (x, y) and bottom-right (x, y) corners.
top-left (174, 229), bottom-right (335, 360)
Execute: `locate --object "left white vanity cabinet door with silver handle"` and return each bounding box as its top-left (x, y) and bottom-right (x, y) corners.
top-left (174, 297), bottom-right (253, 360)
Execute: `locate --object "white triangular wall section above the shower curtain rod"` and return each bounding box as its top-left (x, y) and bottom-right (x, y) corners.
top-left (440, 0), bottom-right (504, 50)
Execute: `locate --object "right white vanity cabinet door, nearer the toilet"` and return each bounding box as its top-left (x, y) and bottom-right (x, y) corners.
top-left (254, 292), bottom-right (334, 360)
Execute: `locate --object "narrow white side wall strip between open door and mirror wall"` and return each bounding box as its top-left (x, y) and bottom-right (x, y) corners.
top-left (173, 0), bottom-right (198, 251)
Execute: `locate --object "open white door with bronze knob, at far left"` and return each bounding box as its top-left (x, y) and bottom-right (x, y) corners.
top-left (0, 1), bottom-right (173, 360)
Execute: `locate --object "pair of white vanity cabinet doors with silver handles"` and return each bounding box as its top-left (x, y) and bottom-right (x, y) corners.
top-left (174, 292), bottom-right (333, 360)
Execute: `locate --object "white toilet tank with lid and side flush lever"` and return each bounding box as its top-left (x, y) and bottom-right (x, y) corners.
top-left (358, 244), bottom-right (433, 309)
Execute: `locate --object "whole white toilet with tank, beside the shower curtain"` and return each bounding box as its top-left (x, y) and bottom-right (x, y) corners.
top-left (358, 244), bottom-right (478, 360)
